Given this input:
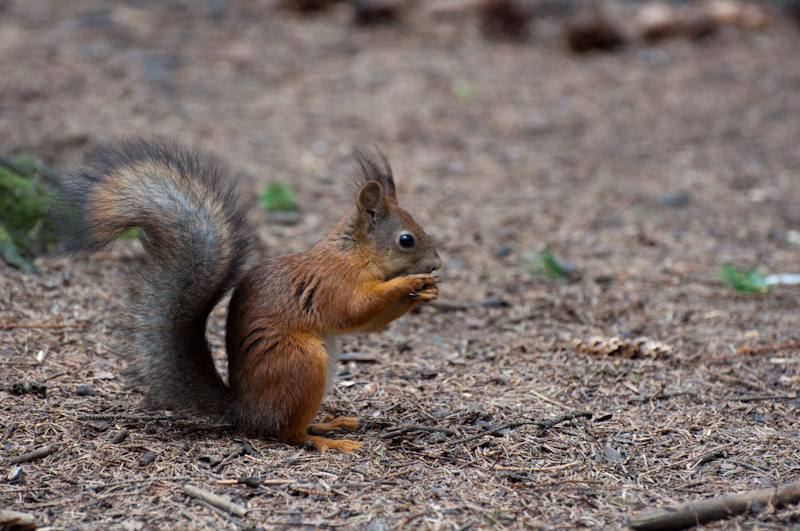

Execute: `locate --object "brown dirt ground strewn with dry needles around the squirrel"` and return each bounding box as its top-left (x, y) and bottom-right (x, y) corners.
top-left (0, 0), bottom-right (800, 530)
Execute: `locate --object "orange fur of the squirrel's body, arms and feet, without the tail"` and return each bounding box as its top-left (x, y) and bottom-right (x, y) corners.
top-left (226, 171), bottom-right (440, 451)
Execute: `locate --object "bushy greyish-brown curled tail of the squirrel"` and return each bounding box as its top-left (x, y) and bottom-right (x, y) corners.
top-left (60, 139), bottom-right (250, 416)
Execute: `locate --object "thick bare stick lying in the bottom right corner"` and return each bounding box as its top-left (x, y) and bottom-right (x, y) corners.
top-left (628, 483), bottom-right (800, 531)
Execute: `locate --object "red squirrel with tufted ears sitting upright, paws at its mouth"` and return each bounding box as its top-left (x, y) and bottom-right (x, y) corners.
top-left (59, 138), bottom-right (442, 453)
